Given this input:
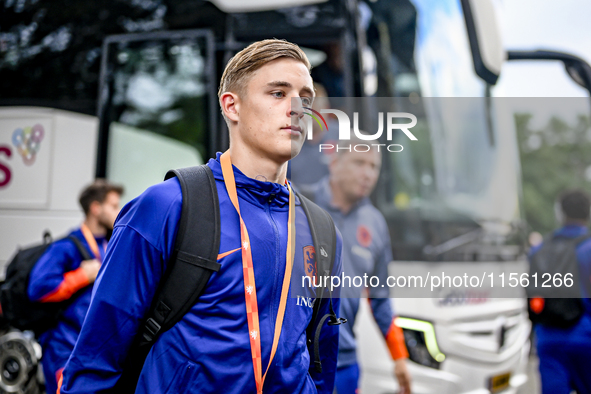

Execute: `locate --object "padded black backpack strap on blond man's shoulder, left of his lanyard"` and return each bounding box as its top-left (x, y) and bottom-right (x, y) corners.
top-left (142, 165), bottom-right (220, 343)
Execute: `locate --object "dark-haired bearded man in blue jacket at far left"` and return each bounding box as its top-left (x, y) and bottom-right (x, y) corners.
top-left (28, 179), bottom-right (123, 393)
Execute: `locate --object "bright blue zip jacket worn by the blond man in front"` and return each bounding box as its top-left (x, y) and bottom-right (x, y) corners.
top-left (61, 154), bottom-right (342, 394)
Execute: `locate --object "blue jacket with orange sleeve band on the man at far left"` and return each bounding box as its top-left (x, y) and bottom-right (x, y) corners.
top-left (27, 229), bottom-right (106, 393)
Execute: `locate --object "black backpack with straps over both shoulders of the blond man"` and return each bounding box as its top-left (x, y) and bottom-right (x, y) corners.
top-left (115, 165), bottom-right (346, 393)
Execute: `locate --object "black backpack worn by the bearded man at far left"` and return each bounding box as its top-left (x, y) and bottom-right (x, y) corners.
top-left (0, 232), bottom-right (92, 334)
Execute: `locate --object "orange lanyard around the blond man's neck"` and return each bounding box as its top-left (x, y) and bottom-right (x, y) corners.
top-left (220, 151), bottom-right (295, 394)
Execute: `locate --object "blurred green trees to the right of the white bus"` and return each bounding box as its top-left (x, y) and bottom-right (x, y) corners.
top-left (515, 114), bottom-right (591, 234)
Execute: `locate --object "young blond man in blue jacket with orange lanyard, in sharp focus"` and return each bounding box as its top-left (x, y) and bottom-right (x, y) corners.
top-left (61, 40), bottom-right (341, 394)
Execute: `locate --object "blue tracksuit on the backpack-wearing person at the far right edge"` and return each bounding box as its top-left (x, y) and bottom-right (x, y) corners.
top-left (531, 225), bottom-right (591, 394)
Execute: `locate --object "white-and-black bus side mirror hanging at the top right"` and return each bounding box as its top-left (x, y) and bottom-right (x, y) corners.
top-left (461, 0), bottom-right (506, 85)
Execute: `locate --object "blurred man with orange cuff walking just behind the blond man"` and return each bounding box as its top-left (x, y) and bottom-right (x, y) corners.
top-left (301, 137), bottom-right (411, 394)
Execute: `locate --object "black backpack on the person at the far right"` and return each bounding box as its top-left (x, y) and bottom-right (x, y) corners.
top-left (527, 234), bottom-right (591, 328)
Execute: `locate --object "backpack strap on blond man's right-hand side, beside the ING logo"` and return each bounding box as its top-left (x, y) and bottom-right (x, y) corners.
top-left (298, 193), bottom-right (347, 372)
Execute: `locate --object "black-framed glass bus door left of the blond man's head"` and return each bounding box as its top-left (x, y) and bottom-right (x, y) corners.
top-left (96, 29), bottom-right (218, 202)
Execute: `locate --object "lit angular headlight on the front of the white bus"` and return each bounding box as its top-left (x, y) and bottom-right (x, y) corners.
top-left (394, 317), bottom-right (445, 369)
